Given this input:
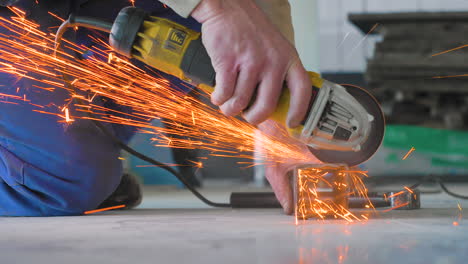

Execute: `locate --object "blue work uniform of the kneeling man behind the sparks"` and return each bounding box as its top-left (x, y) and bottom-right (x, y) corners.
top-left (0, 0), bottom-right (200, 216)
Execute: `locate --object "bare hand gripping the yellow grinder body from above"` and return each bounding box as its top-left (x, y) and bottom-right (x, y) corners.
top-left (192, 0), bottom-right (311, 127)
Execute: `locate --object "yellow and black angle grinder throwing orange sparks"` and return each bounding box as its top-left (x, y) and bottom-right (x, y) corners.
top-left (57, 7), bottom-right (385, 166)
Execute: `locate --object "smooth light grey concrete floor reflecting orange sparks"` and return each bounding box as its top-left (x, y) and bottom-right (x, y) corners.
top-left (0, 185), bottom-right (468, 264)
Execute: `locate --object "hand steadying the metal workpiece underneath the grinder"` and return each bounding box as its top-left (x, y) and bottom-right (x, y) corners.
top-left (259, 120), bottom-right (321, 214)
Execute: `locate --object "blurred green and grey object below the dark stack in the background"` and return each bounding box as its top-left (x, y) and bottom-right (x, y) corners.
top-left (360, 125), bottom-right (468, 174)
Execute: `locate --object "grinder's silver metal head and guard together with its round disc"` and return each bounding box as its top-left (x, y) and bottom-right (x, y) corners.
top-left (308, 82), bottom-right (385, 166)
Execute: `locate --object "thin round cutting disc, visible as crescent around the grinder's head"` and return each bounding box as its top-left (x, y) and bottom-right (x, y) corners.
top-left (309, 85), bottom-right (385, 166)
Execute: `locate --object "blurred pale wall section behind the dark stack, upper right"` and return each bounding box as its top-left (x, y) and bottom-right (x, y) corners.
top-left (320, 0), bottom-right (468, 72)
